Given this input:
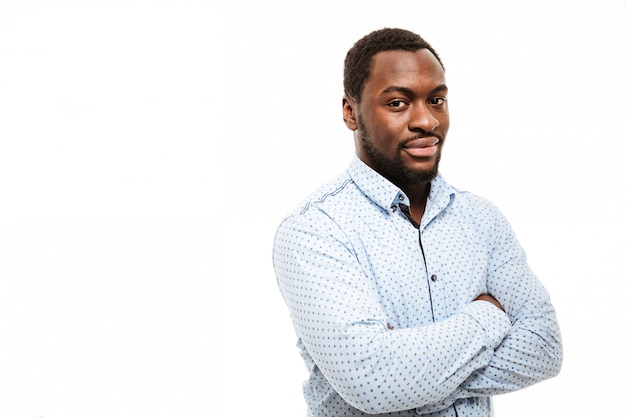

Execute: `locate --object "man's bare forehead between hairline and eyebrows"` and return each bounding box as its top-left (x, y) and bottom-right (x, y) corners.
top-left (363, 49), bottom-right (445, 93)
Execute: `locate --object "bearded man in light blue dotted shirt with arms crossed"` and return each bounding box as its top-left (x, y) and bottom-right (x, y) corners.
top-left (274, 29), bottom-right (562, 417)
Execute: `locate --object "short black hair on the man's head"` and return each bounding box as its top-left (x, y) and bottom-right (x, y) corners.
top-left (343, 28), bottom-right (445, 103)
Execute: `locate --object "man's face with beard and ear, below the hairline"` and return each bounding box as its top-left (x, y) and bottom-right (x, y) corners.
top-left (344, 49), bottom-right (450, 187)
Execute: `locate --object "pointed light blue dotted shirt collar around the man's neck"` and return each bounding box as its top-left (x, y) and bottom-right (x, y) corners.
top-left (348, 156), bottom-right (456, 225)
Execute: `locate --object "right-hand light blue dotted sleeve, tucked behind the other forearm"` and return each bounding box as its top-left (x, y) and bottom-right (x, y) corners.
top-left (418, 205), bottom-right (563, 413)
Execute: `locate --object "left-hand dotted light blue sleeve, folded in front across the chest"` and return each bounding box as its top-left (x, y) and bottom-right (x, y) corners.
top-left (274, 208), bottom-right (511, 414)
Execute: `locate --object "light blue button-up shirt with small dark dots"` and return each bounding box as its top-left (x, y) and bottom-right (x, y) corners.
top-left (274, 158), bottom-right (562, 417)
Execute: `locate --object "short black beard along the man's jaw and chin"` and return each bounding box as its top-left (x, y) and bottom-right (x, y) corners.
top-left (357, 115), bottom-right (441, 186)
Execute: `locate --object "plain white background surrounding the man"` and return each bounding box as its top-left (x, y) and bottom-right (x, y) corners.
top-left (0, 0), bottom-right (626, 417)
